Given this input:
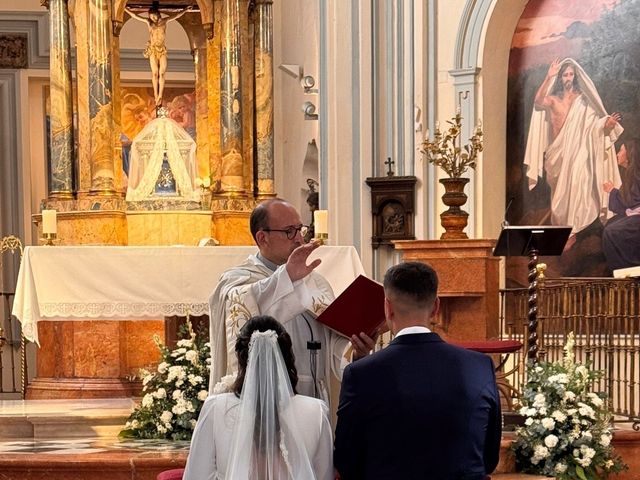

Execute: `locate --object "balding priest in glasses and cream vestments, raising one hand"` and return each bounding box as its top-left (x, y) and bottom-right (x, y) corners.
top-left (209, 199), bottom-right (375, 403)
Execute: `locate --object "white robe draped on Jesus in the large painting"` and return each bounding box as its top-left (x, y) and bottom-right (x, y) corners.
top-left (524, 59), bottom-right (624, 234)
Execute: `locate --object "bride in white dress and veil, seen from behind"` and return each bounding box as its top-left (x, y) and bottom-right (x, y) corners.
top-left (183, 316), bottom-right (334, 480)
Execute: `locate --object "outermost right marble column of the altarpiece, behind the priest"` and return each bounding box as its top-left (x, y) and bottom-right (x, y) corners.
top-left (254, 0), bottom-right (276, 199)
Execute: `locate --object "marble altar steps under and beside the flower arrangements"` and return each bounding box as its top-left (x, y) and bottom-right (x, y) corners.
top-left (0, 398), bottom-right (640, 480)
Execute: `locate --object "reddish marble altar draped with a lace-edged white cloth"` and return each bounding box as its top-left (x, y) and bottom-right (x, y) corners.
top-left (13, 246), bottom-right (364, 399)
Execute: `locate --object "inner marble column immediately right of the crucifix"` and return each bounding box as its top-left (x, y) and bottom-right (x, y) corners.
top-left (220, 0), bottom-right (245, 196)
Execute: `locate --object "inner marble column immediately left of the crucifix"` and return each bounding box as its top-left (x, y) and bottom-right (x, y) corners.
top-left (88, 0), bottom-right (115, 196)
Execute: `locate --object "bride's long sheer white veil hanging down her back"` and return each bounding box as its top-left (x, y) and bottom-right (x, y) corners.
top-left (225, 330), bottom-right (315, 480)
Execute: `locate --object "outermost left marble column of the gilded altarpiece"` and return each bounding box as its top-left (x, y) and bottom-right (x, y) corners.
top-left (43, 0), bottom-right (75, 199)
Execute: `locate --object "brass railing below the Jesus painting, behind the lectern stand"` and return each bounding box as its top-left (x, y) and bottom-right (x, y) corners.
top-left (500, 278), bottom-right (640, 429)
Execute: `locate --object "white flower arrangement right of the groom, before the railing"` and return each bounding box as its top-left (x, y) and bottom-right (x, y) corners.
top-left (512, 333), bottom-right (627, 480)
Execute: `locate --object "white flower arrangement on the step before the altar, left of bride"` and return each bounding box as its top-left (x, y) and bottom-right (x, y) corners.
top-left (120, 321), bottom-right (211, 440)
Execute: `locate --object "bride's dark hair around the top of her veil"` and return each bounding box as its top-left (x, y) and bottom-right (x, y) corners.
top-left (232, 315), bottom-right (298, 397)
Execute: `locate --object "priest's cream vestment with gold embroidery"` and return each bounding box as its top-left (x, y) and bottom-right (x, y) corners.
top-left (209, 255), bottom-right (350, 403)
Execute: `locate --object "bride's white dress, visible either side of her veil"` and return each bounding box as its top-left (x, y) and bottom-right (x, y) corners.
top-left (183, 393), bottom-right (334, 480)
